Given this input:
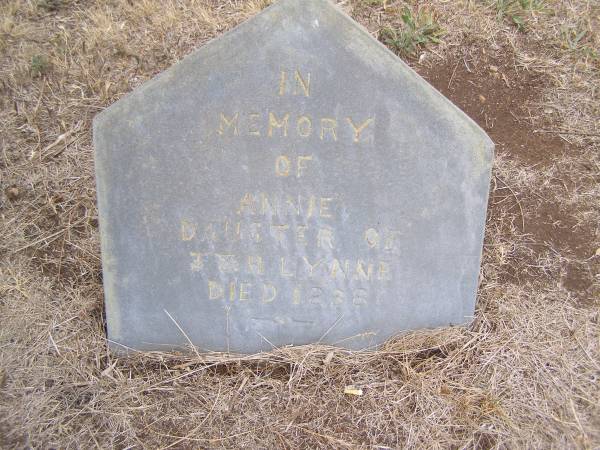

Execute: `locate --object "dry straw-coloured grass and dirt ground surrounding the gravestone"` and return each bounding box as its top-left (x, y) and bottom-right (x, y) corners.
top-left (0, 0), bottom-right (600, 448)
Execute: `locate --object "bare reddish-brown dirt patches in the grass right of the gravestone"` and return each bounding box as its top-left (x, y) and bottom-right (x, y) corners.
top-left (416, 51), bottom-right (594, 303)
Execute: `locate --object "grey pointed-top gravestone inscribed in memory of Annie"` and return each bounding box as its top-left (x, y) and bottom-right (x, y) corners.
top-left (94, 0), bottom-right (493, 352)
